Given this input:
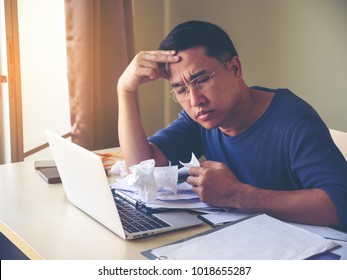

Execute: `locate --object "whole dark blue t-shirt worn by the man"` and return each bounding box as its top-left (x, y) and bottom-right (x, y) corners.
top-left (149, 88), bottom-right (347, 230)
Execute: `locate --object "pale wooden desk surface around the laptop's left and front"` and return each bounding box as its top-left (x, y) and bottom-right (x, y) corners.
top-left (0, 149), bottom-right (210, 260)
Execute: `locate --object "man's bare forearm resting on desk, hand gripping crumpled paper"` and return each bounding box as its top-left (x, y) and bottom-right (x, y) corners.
top-left (187, 161), bottom-right (339, 229)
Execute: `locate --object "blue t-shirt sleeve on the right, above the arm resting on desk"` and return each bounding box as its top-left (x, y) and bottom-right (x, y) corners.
top-left (288, 117), bottom-right (347, 230)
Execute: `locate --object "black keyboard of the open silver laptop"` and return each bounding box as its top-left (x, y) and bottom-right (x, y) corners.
top-left (114, 195), bottom-right (170, 233)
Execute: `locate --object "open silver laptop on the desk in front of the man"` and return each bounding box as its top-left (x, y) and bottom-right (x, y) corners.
top-left (45, 130), bottom-right (203, 239)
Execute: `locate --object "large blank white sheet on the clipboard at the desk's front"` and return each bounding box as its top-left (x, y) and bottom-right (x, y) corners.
top-left (151, 214), bottom-right (337, 260)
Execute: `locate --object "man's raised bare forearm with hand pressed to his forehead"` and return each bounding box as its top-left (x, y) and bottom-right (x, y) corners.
top-left (117, 51), bottom-right (179, 167)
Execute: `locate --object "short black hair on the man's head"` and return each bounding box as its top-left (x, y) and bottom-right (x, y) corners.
top-left (159, 21), bottom-right (237, 62)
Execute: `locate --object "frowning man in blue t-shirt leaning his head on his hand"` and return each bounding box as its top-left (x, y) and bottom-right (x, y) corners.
top-left (118, 21), bottom-right (347, 230)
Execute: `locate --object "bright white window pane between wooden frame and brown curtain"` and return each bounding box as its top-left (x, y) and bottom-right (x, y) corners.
top-left (18, 0), bottom-right (71, 152)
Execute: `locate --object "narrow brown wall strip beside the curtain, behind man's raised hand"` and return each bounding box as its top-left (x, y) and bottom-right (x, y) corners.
top-left (133, 0), bottom-right (180, 136)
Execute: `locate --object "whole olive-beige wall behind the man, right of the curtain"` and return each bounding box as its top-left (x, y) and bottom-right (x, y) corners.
top-left (134, 0), bottom-right (347, 134)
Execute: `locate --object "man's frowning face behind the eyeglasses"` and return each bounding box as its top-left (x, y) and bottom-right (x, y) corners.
top-left (167, 47), bottom-right (241, 129)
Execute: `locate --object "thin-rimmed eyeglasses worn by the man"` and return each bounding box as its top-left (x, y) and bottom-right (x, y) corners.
top-left (169, 61), bottom-right (227, 102)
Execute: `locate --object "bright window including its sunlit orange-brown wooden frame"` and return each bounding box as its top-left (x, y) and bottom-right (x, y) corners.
top-left (0, 0), bottom-right (71, 162)
